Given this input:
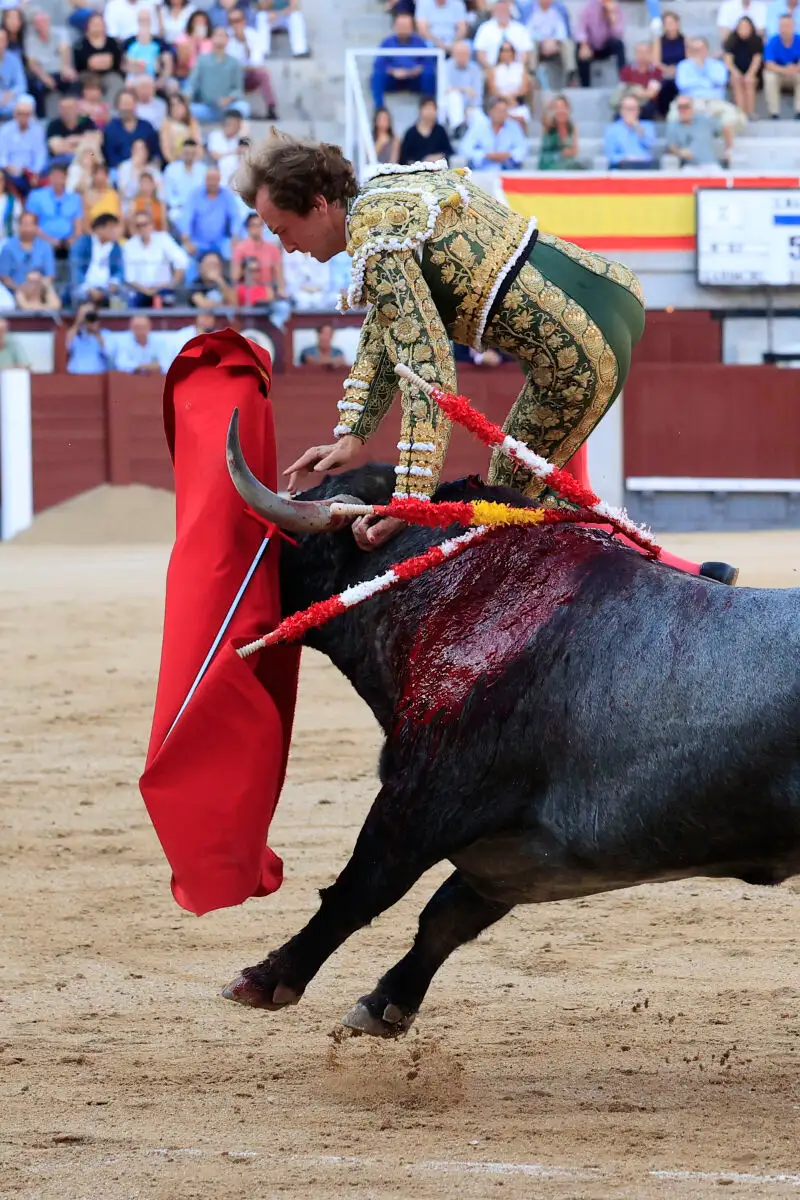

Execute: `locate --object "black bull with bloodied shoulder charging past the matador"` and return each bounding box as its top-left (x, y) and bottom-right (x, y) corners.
top-left (223, 436), bottom-right (800, 1036)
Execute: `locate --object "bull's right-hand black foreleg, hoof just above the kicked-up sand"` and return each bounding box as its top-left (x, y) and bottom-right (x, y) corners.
top-left (342, 871), bottom-right (513, 1038)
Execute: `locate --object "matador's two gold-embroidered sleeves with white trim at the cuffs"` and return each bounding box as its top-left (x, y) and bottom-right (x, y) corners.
top-left (336, 250), bottom-right (456, 499)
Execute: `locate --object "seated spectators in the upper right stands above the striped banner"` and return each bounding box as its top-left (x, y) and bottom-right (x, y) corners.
top-left (372, 0), bottom-right (800, 170)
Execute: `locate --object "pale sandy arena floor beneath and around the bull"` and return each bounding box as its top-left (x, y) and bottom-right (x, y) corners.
top-left (0, 518), bottom-right (800, 1200)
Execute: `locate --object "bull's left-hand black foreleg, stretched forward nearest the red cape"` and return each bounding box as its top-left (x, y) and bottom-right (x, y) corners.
top-left (222, 781), bottom-right (473, 1009)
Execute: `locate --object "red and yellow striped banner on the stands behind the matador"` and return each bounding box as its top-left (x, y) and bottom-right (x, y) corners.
top-left (500, 172), bottom-right (800, 251)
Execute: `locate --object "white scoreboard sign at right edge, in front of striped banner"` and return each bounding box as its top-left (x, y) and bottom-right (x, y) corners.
top-left (697, 187), bottom-right (800, 288)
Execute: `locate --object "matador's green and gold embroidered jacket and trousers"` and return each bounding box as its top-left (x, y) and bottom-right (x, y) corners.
top-left (335, 163), bottom-right (644, 498)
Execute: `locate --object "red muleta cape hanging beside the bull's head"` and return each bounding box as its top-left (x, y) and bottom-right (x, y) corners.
top-left (139, 329), bottom-right (300, 916)
